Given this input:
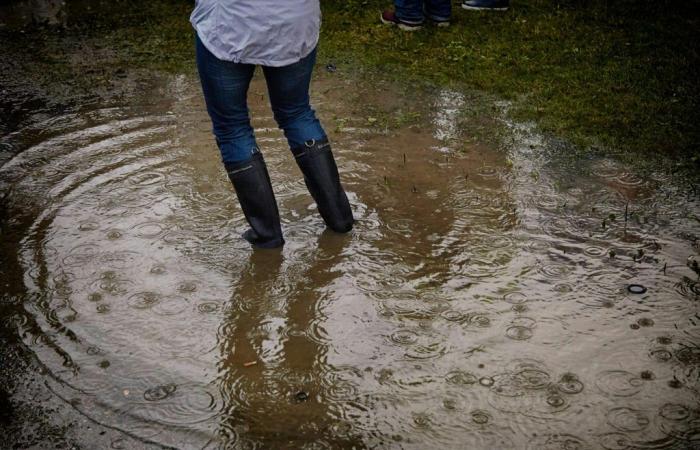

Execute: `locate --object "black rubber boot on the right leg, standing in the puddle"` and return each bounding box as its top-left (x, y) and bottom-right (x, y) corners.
top-left (292, 139), bottom-right (354, 233)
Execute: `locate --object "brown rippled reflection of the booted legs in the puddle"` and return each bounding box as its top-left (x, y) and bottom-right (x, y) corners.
top-left (220, 231), bottom-right (361, 448)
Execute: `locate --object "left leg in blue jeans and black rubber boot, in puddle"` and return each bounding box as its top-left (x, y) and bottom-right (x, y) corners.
top-left (196, 38), bottom-right (284, 248)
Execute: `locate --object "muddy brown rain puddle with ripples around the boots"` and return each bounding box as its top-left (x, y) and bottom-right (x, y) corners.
top-left (0, 65), bottom-right (700, 450)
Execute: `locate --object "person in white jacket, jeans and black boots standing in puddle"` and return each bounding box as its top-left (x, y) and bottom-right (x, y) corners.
top-left (190, 0), bottom-right (354, 248)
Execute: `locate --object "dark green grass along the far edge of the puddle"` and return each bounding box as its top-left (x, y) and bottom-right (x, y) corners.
top-left (3, 0), bottom-right (700, 172)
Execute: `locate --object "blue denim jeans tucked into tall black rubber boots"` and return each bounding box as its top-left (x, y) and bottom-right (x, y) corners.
top-left (196, 37), bottom-right (326, 164)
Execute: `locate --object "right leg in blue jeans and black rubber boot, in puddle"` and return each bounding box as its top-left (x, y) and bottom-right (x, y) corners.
top-left (263, 49), bottom-right (353, 233)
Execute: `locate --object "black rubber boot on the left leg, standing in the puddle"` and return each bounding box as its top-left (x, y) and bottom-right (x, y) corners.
top-left (226, 152), bottom-right (284, 248)
